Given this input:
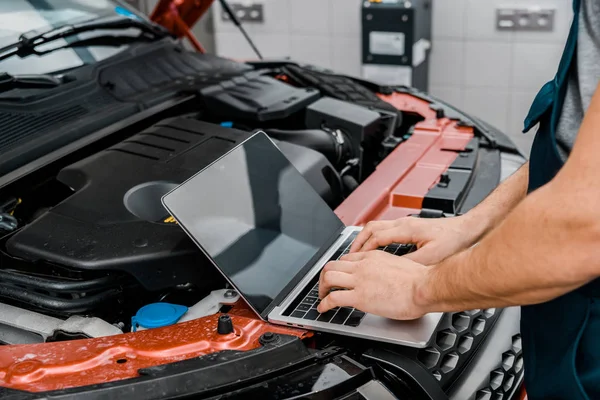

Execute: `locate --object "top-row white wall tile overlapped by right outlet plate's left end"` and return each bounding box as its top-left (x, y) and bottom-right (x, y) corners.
top-left (466, 0), bottom-right (520, 42)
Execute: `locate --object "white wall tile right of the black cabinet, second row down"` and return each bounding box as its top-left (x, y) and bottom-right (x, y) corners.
top-left (429, 39), bottom-right (465, 85)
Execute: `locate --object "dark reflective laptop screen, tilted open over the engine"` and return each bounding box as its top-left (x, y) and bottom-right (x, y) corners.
top-left (164, 133), bottom-right (343, 314)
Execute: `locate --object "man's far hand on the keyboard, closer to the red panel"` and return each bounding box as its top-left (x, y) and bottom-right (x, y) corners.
top-left (350, 216), bottom-right (480, 265)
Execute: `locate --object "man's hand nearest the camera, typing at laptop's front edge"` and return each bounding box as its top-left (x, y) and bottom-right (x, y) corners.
top-left (318, 251), bottom-right (428, 320)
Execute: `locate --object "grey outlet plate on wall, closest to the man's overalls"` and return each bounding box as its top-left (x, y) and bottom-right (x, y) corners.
top-left (496, 7), bottom-right (556, 32)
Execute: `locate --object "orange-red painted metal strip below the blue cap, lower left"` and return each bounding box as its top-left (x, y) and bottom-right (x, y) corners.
top-left (0, 302), bottom-right (311, 392)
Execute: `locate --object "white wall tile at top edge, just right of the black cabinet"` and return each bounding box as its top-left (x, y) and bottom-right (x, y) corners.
top-left (432, 0), bottom-right (467, 39)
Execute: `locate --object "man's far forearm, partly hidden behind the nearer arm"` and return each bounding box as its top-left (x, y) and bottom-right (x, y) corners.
top-left (461, 162), bottom-right (529, 242)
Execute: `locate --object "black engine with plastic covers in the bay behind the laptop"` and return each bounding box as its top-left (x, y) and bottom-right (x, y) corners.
top-left (0, 65), bottom-right (415, 344)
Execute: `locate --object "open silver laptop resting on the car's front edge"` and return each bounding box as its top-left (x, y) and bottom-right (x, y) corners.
top-left (162, 132), bottom-right (442, 348)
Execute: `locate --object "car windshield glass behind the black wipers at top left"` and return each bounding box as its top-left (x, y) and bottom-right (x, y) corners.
top-left (0, 0), bottom-right (149, 75)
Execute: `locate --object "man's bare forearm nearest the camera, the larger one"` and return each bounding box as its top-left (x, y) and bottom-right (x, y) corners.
top-left (417, 178), bottom-right (600, 311)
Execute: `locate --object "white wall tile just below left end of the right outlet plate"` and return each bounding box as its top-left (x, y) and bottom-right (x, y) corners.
top-left (464, 42), bottom-right (512, 88)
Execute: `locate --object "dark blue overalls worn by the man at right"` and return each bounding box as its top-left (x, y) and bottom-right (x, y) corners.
top-left (521, 0), bottom-right (600, 400)
